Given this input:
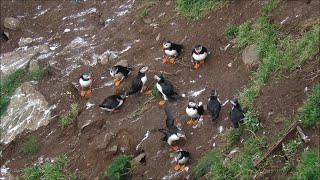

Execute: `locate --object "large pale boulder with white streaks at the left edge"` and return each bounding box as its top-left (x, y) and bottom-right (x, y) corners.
top-left (0, 81), bottom-right (54, 144)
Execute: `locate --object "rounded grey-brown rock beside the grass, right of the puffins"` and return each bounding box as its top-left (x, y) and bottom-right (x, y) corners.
top-left (242, 44), bottom-right (259, 70)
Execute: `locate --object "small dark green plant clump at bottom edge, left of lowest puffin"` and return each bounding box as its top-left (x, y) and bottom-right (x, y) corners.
top-left (105, 155), bottom-right (131, 180)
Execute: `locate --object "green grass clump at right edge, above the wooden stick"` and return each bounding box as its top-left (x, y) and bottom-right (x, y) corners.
top-left (298, 84), bottom-right (320, 127)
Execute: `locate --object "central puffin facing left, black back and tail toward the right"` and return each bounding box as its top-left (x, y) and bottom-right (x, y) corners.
top-left (154, 75), bottom-right (181, 105)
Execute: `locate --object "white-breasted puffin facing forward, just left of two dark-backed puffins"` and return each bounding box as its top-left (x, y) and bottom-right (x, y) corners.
top-left (186, 100), bottom-right (204, 125)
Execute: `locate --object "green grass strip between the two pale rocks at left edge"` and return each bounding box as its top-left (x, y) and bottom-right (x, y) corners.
top-left (0, 68), bottom-right (49, 116)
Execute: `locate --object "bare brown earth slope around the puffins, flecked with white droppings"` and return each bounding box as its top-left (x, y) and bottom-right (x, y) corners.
top-left (1, 0), bottom-right (319, 179)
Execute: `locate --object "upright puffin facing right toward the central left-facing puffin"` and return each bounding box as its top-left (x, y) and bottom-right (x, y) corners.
top-left (128, 66), bottom-right (152, 95)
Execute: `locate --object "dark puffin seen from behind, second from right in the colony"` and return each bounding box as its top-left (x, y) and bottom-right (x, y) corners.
top-left (207, 90), bottom-right (221, 123)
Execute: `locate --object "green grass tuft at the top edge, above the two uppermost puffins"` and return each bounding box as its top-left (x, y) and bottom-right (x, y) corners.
top-left (176, 0), bottom-right (223, 19)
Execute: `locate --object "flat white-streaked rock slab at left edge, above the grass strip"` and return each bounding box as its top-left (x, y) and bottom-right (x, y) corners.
top-left (0, 44), bottom-right (50, 78)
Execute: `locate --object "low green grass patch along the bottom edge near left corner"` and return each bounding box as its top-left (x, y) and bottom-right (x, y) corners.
top-left (22, 157), bottom-right (76, 180)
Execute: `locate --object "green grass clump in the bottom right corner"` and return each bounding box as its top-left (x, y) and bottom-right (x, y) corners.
top-left (290, 148), bottom-right (320, 180)
